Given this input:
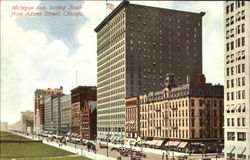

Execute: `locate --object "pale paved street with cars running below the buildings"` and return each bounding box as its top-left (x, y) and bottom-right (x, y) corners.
top-left (17, 136), bottom-right (223, 160)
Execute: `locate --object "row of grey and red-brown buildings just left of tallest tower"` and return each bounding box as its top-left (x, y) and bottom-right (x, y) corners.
top-left (34, 86), bottom-right (96, 139)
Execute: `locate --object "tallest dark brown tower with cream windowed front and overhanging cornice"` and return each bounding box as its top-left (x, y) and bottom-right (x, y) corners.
top-left (95, 1), bottom-right (205, 136)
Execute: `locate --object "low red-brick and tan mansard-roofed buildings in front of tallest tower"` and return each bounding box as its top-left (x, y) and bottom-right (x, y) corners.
top-left (125, 74), bottom-right (224, 152)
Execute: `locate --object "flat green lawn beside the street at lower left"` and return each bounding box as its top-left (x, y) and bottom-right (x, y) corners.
top-left (0, 131), bottom-right (89, 160)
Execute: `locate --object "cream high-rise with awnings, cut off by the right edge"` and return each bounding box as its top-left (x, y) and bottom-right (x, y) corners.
top-left (224, 0), bottom-right (250, 160)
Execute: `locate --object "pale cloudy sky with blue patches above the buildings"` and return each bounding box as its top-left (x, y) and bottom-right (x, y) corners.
top-left (1, 1), bottom-right (224, 123)
